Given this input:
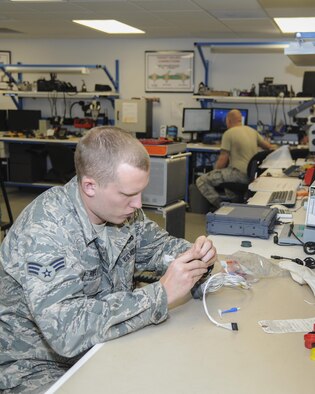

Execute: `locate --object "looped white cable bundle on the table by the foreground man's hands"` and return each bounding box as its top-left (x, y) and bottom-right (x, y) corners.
top-left (202, 272), bottom-right (250, 331)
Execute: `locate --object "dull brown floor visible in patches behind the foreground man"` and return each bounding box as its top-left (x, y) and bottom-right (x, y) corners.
top-left (1, 188), bottom-right (206, 242)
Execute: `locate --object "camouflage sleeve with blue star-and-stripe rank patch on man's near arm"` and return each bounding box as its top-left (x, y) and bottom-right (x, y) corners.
top-left (4, 225), bottom-right (168, 357)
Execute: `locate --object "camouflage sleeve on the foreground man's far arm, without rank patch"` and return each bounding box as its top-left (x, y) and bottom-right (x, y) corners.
top-left (136, 213), bottom-right (191, 275)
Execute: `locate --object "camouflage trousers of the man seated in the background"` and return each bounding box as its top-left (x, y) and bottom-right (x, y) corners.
top-left (196, 167), bottom-right (248, 208)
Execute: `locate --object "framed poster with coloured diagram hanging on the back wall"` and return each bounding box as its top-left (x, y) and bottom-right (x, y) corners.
top-left (145, 51), bottom-right (194, 93)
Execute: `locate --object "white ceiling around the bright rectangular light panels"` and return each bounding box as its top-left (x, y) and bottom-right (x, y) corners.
top-left (0, 0), bottom-right (315, 42)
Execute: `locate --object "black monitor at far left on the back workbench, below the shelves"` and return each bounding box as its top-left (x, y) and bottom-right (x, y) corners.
top-left (7, 109), bottom-right (41, 131)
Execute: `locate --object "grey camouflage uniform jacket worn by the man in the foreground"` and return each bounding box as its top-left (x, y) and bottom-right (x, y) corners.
top-left (0, 178), bottom-right (190, 391)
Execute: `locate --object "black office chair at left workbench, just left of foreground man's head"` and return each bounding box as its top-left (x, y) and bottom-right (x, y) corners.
top-left (45, 143), bottom-right (75, 183)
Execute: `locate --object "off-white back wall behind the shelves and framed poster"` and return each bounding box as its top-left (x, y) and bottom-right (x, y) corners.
top-left (0, 38), bottom-right (314, 136)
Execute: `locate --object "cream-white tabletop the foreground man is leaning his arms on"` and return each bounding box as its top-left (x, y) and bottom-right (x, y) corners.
top-left (49, 209), bottom-right (315, 394)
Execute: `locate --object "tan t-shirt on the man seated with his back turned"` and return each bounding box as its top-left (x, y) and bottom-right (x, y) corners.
top-left (221, 126), bottom-right (263, 174)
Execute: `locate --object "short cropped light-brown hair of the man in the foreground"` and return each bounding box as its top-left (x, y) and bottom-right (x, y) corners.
top-left (74, 126), bottom-right (150, 186)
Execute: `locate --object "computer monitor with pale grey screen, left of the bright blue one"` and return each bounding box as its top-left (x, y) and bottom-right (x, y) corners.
top-left (182, 108), bottom-right (212, 142)
